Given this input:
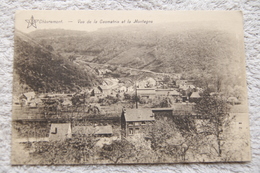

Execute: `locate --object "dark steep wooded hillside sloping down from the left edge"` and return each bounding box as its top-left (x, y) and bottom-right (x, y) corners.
top-left (14, 31), bottom-right (99, 92)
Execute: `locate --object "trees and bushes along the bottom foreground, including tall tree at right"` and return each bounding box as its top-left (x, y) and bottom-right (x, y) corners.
top-left (13, 94), bottom-right (248, 164)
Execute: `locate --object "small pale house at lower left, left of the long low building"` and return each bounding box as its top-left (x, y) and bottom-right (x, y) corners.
top-left (49, 123), bottom-right (72, 141)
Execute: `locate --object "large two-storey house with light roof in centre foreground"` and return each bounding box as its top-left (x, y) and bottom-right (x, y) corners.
top-left (121, 109), bottom-right (155, 136)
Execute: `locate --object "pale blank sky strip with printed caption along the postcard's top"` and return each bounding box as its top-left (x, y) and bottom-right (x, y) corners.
top-left (15, 10), bottom-right (243, 33)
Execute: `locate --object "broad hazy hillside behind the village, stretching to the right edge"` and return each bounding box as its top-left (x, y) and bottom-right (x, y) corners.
top-left (27, 23), bottom-right (245, 92)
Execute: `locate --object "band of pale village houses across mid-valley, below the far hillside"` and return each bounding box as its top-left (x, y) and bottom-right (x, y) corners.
top-left (90, 77), bottom-right (203, 102)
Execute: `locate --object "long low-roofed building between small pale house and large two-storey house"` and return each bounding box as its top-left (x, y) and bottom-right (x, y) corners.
top-left (72, 125), bottom-right (113, 137)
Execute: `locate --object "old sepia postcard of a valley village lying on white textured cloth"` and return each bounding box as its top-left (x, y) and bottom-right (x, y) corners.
top-left (11, 11), bottom-right (251, 165)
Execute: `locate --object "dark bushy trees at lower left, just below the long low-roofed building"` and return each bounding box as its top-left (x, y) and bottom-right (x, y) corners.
top-left (32, 135), bottom-right (98, 164)
